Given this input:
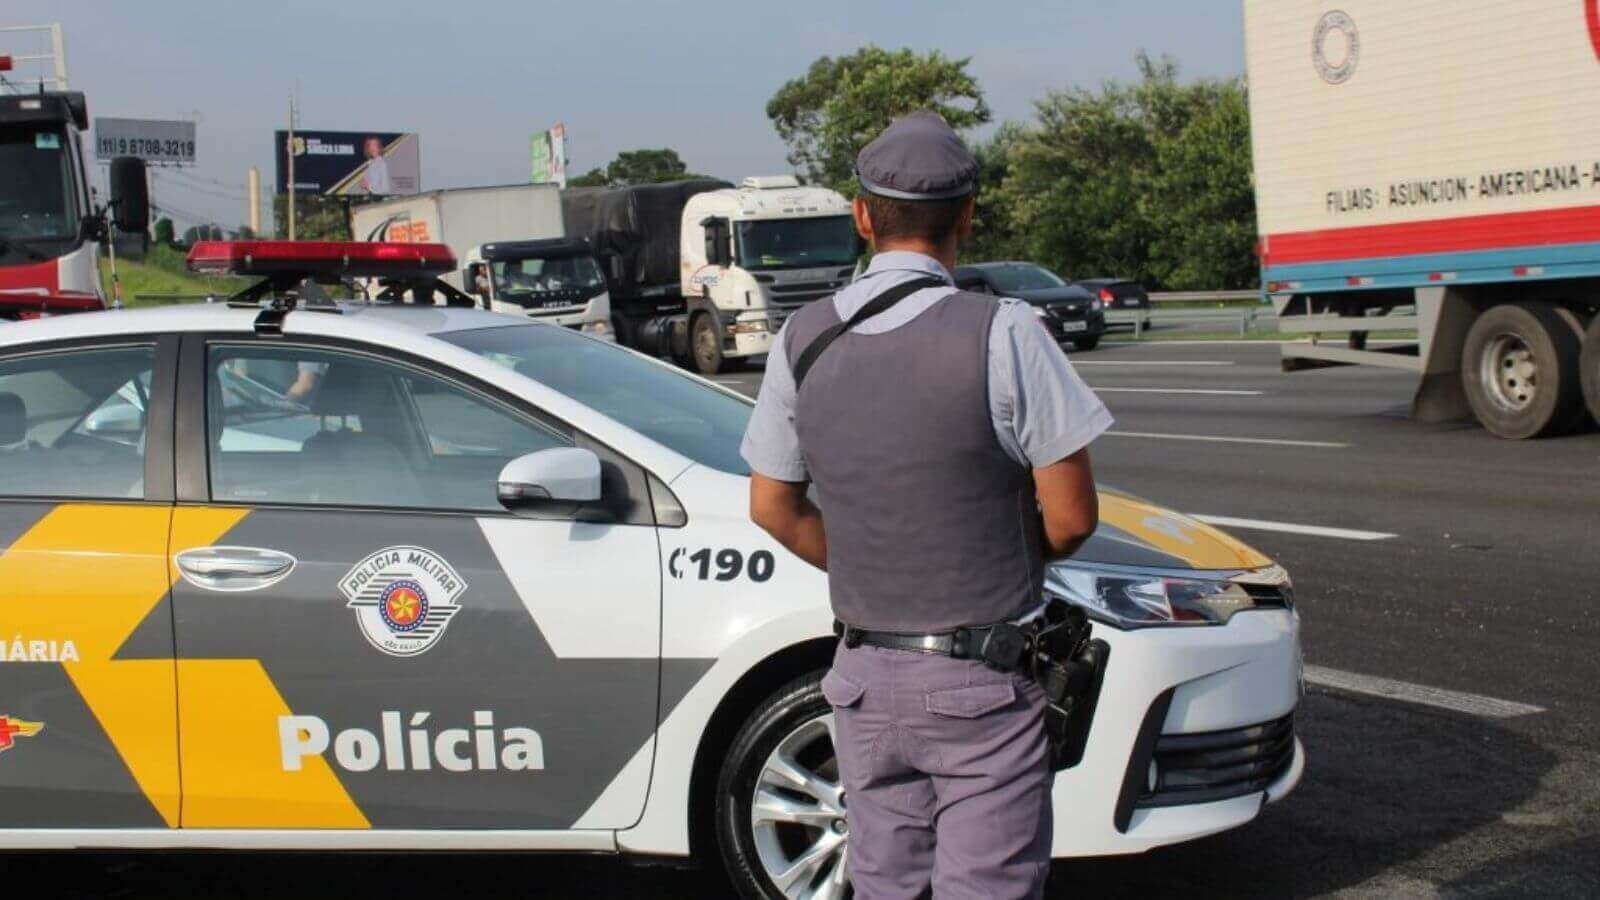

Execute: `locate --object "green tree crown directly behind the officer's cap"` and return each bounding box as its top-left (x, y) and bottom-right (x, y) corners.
top-left (766, 45), bottom-right (989, 195)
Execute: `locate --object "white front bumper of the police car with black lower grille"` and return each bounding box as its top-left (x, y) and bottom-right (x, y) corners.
top-left (1053, 610), bottom-right (1306, 857)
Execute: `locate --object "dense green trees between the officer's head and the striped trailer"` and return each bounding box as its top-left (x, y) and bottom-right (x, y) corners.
top-left (970, 53), bottom-right (1258, 290)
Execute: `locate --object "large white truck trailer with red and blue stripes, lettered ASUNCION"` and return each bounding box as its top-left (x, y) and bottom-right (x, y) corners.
top-left (1245, 0), bottom-right (1600, 439)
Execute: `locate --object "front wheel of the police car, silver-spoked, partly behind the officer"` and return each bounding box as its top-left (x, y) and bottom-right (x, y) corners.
top-left (717, 669), bottom-right (850, 900)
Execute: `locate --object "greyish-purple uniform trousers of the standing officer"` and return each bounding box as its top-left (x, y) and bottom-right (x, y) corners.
top-left (822, 644), bottom-right (1054, 900)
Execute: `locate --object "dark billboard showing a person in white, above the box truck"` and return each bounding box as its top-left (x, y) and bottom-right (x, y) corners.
top-left (272, 131), bottom-right (422, 197)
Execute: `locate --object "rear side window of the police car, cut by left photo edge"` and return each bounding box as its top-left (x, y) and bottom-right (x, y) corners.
top-left (0, 348), bottom-right (155, 500)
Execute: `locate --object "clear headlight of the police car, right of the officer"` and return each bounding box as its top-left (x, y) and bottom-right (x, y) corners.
top-left (1045, 562), bottom-right (1294, 628)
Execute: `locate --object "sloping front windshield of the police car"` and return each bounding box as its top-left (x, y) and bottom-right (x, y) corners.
top-left (438, 323), bottom-right (750, 476)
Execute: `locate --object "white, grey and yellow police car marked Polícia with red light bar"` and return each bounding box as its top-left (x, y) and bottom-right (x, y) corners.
top-left (0, 242), bottom-right (1304, 897)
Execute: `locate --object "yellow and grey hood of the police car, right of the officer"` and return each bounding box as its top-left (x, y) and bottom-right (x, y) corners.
top-left (1072, 487), bottom-right (1272, 570)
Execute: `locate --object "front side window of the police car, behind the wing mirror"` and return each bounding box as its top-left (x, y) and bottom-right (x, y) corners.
top-left (206, 344), bottom-right (571, 511)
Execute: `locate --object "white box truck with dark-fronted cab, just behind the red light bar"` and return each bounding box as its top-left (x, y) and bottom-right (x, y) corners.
top-left (350, 184), bottom-right (611, 340)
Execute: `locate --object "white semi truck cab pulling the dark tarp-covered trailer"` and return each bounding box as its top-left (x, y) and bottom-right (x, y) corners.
top-left (680, 175), bottom-right (862, 373)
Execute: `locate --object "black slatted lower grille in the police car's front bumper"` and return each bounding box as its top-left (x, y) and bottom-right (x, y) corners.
top-left (1136, 713), bottom-right (1294, 809)
